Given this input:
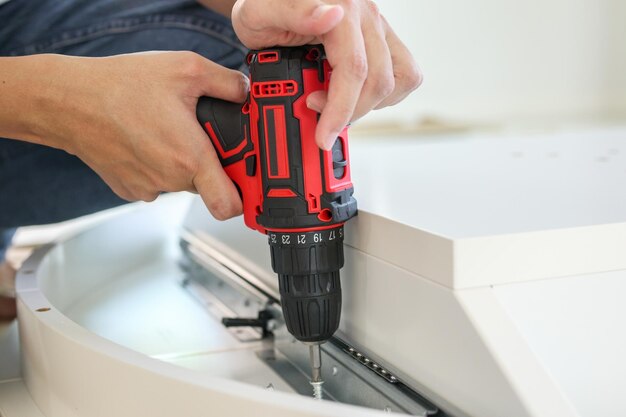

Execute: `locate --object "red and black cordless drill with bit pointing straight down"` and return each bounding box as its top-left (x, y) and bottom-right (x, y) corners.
top-left (197, 45), bottom-right (357, 398)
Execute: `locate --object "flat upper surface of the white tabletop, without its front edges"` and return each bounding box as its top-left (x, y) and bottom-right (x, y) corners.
top-left (351, 128), bottom-right (626, 239)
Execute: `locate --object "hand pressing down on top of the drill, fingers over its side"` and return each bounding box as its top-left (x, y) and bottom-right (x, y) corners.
top-left (232, 0), bottom-right (422, 149)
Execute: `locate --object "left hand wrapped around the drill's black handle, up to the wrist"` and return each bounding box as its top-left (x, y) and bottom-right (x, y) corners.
top-left (24, 52), bottom-right (248, 219)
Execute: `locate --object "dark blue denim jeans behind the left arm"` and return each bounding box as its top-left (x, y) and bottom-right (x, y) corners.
top-left (0, 0), bottom-right (246, 261)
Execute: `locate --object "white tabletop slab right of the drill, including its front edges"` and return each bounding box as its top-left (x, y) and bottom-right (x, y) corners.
top-left (346, 126), bottom-right (626, 288)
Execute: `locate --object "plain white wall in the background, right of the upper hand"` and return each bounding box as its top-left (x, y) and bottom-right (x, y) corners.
top-left (368, 0), bottom-right (626, 123)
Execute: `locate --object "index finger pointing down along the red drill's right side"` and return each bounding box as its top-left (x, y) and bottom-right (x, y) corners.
top-left (315, 15), bottom-right (367, 150)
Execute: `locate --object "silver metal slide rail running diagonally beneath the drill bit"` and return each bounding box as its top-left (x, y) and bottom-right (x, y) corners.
top-left (181, 233), bottom-right (448, 417)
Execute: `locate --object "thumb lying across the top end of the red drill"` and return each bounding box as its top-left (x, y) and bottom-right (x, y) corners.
top-left (239, 0), bottom-right (344, 36)
